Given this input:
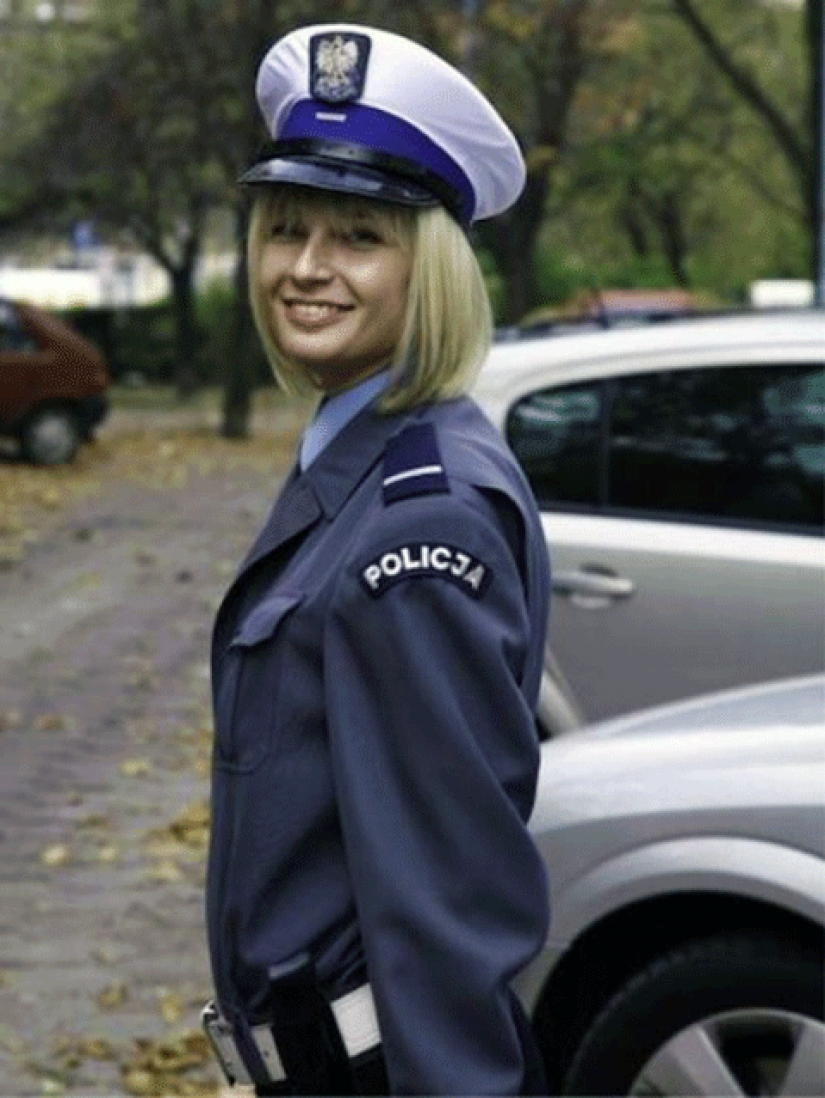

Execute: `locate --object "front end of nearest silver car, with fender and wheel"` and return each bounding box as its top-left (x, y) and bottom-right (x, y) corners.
top-left (517, 675), bottom-right (825, 1096)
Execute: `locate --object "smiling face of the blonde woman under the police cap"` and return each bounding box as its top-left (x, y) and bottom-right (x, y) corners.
top-left (258, 200), bottom-right (412, 392)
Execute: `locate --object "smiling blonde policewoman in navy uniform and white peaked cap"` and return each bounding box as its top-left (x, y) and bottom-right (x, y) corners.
top-left (204, 25), bottom-right (548, 1095)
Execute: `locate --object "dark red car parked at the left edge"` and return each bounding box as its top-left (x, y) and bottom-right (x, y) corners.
top-left (0, 300), bottom-right (110, 464)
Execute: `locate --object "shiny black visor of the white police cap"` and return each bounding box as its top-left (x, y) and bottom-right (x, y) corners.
top-left (238, 141), bottom-right (466, 223)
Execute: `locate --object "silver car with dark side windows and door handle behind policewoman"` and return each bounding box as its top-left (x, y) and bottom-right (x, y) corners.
top-left (476, 310), bottom-right (825, 731)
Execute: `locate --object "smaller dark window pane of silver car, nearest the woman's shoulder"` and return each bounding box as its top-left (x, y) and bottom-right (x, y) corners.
top-left (506, 382), bottom-right (603, 506)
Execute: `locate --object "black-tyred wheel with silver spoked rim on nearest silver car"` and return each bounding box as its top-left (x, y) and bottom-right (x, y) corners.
top-left (564, 933), bottom-right (825, 1095)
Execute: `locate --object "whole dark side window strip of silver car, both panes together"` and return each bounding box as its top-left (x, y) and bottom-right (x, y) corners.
top-left (506, 363), bottom-right (825, 531)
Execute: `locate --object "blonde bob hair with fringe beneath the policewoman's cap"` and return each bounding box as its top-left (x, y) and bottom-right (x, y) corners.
top-left (247, 184), bottom-right (492, 412)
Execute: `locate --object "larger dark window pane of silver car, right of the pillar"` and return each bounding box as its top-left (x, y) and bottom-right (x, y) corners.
top-left (607, 365), bottom-right (825, 527)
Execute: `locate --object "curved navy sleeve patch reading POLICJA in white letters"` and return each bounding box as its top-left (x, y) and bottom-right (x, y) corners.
top-left (358, 541), bottom-right (492, 598)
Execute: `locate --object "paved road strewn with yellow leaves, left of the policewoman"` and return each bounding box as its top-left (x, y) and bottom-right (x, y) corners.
top-left (0, 404), bottom-right (300, 1098)
